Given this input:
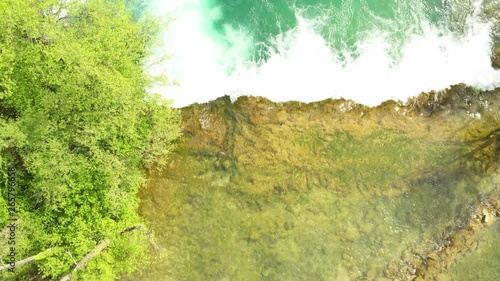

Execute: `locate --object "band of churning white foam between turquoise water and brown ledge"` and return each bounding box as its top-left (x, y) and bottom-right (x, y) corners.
top-left (147, 0), bottom-right (500, 107)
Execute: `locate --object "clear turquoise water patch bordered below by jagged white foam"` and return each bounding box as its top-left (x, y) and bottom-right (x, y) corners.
top-left (213, 0), bottom-right (446, 61)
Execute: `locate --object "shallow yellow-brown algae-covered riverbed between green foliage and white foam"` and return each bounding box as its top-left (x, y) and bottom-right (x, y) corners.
top-left (130, 85), bottom-right (500, 280)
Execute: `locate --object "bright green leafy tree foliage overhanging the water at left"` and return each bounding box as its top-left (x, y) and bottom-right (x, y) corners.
top-left (0, 0), bottom-right (180, 280)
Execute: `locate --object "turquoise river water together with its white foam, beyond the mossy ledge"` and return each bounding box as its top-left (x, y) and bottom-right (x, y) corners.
top-left (130, 0), bottom-right (500, 106)
